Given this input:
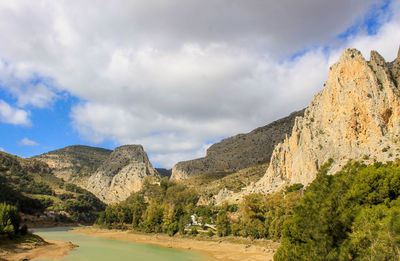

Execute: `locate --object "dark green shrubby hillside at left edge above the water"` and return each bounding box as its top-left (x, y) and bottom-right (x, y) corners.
top-left (0, 152), bottom-right (105, 225)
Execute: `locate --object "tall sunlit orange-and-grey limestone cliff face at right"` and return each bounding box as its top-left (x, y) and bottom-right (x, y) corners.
top-left (252, 49), bottom-right (400, 193)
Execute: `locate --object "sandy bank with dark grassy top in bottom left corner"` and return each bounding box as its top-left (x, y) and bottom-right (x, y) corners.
top-left (0, 235), bottom-right (77, 261)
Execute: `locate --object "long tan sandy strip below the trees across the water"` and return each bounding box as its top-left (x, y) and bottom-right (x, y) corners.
top-left (73, 227), bottom-right (279, 261)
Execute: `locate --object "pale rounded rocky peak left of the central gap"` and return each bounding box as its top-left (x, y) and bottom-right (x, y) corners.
top-left (87, 145), bottom-right (159, 203)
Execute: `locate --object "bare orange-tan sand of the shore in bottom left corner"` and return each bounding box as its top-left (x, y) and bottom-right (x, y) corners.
top-left (0, 240), bottom-right (76, 261)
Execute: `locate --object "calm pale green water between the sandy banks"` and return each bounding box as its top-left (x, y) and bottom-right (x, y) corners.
top-left (34, 225), bottom-right (213, 261)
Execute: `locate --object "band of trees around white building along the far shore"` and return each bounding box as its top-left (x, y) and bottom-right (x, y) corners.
top-left (96, 174), bottom-right (301, 240)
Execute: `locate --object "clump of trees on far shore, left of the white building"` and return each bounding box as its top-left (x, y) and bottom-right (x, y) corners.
top-left (97, 178), bottom-right (198, 235)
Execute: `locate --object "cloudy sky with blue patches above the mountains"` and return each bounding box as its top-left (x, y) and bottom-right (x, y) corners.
top-left (0, 0), bottom-right (400, 168)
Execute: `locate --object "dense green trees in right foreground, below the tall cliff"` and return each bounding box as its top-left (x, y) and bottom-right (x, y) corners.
top-left (274, 162), bottom-right (400, 261)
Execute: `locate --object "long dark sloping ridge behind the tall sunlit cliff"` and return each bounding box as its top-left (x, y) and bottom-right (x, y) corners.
top-left (171, 110), bottom-right (304, 180)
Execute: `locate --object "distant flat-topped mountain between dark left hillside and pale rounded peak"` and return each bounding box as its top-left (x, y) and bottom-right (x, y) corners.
top-left (33, 145), bottom-right (112, 188)
